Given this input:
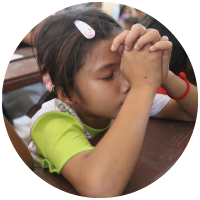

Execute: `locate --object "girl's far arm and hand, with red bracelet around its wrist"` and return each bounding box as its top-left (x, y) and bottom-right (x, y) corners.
top-left (138, 32), bottom-right (198, 122)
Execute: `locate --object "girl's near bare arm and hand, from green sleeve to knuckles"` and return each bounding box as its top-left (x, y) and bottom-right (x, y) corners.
top-left (61, 26), bottom-right (162, 198)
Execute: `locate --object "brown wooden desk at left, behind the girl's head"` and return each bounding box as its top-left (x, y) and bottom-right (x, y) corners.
top-left (2, 47), bottom-right (41, 93)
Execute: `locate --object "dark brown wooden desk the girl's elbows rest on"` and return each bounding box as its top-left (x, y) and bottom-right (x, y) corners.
top-left (35, 118), bottom-right (195, 196)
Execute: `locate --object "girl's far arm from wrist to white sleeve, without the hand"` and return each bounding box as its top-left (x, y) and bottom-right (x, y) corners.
top-left (154, 71), bottom-right (198, 122)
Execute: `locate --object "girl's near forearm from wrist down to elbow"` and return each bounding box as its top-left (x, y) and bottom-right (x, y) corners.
top-left (83, 84), bottom-right (156, 196)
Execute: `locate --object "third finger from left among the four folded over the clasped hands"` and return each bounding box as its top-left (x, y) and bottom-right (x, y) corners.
top-left (134, 29), bottom-right (161, 50)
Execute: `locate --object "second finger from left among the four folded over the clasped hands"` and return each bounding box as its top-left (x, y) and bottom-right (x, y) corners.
top-left (125, 24), bottom-right (146, 51)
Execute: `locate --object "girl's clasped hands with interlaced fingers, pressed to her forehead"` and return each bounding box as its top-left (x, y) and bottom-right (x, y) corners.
top-left (111, 24), bottom-right (172, 86)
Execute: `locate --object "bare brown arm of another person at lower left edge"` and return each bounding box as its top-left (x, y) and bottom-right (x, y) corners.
top-left (3, 115), bottom-right (34, 172)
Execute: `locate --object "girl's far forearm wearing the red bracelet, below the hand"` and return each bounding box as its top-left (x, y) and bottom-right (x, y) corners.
top-left (162, 72), bottom-right (198, 121)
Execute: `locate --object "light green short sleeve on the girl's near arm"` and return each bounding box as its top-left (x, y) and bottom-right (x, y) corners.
top-left (31, 111), bottom-right (94, 174)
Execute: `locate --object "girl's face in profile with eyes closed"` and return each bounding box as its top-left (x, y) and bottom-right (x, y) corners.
top-left (72, 39), bottom-right (130, 129)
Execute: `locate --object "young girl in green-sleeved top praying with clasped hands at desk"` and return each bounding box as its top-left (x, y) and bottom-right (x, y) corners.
top-left (29, 7), bottom-right (197, 198)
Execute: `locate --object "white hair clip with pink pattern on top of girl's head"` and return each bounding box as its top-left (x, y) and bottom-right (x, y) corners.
top-left (74, 20), bottom-right (95, 39)
